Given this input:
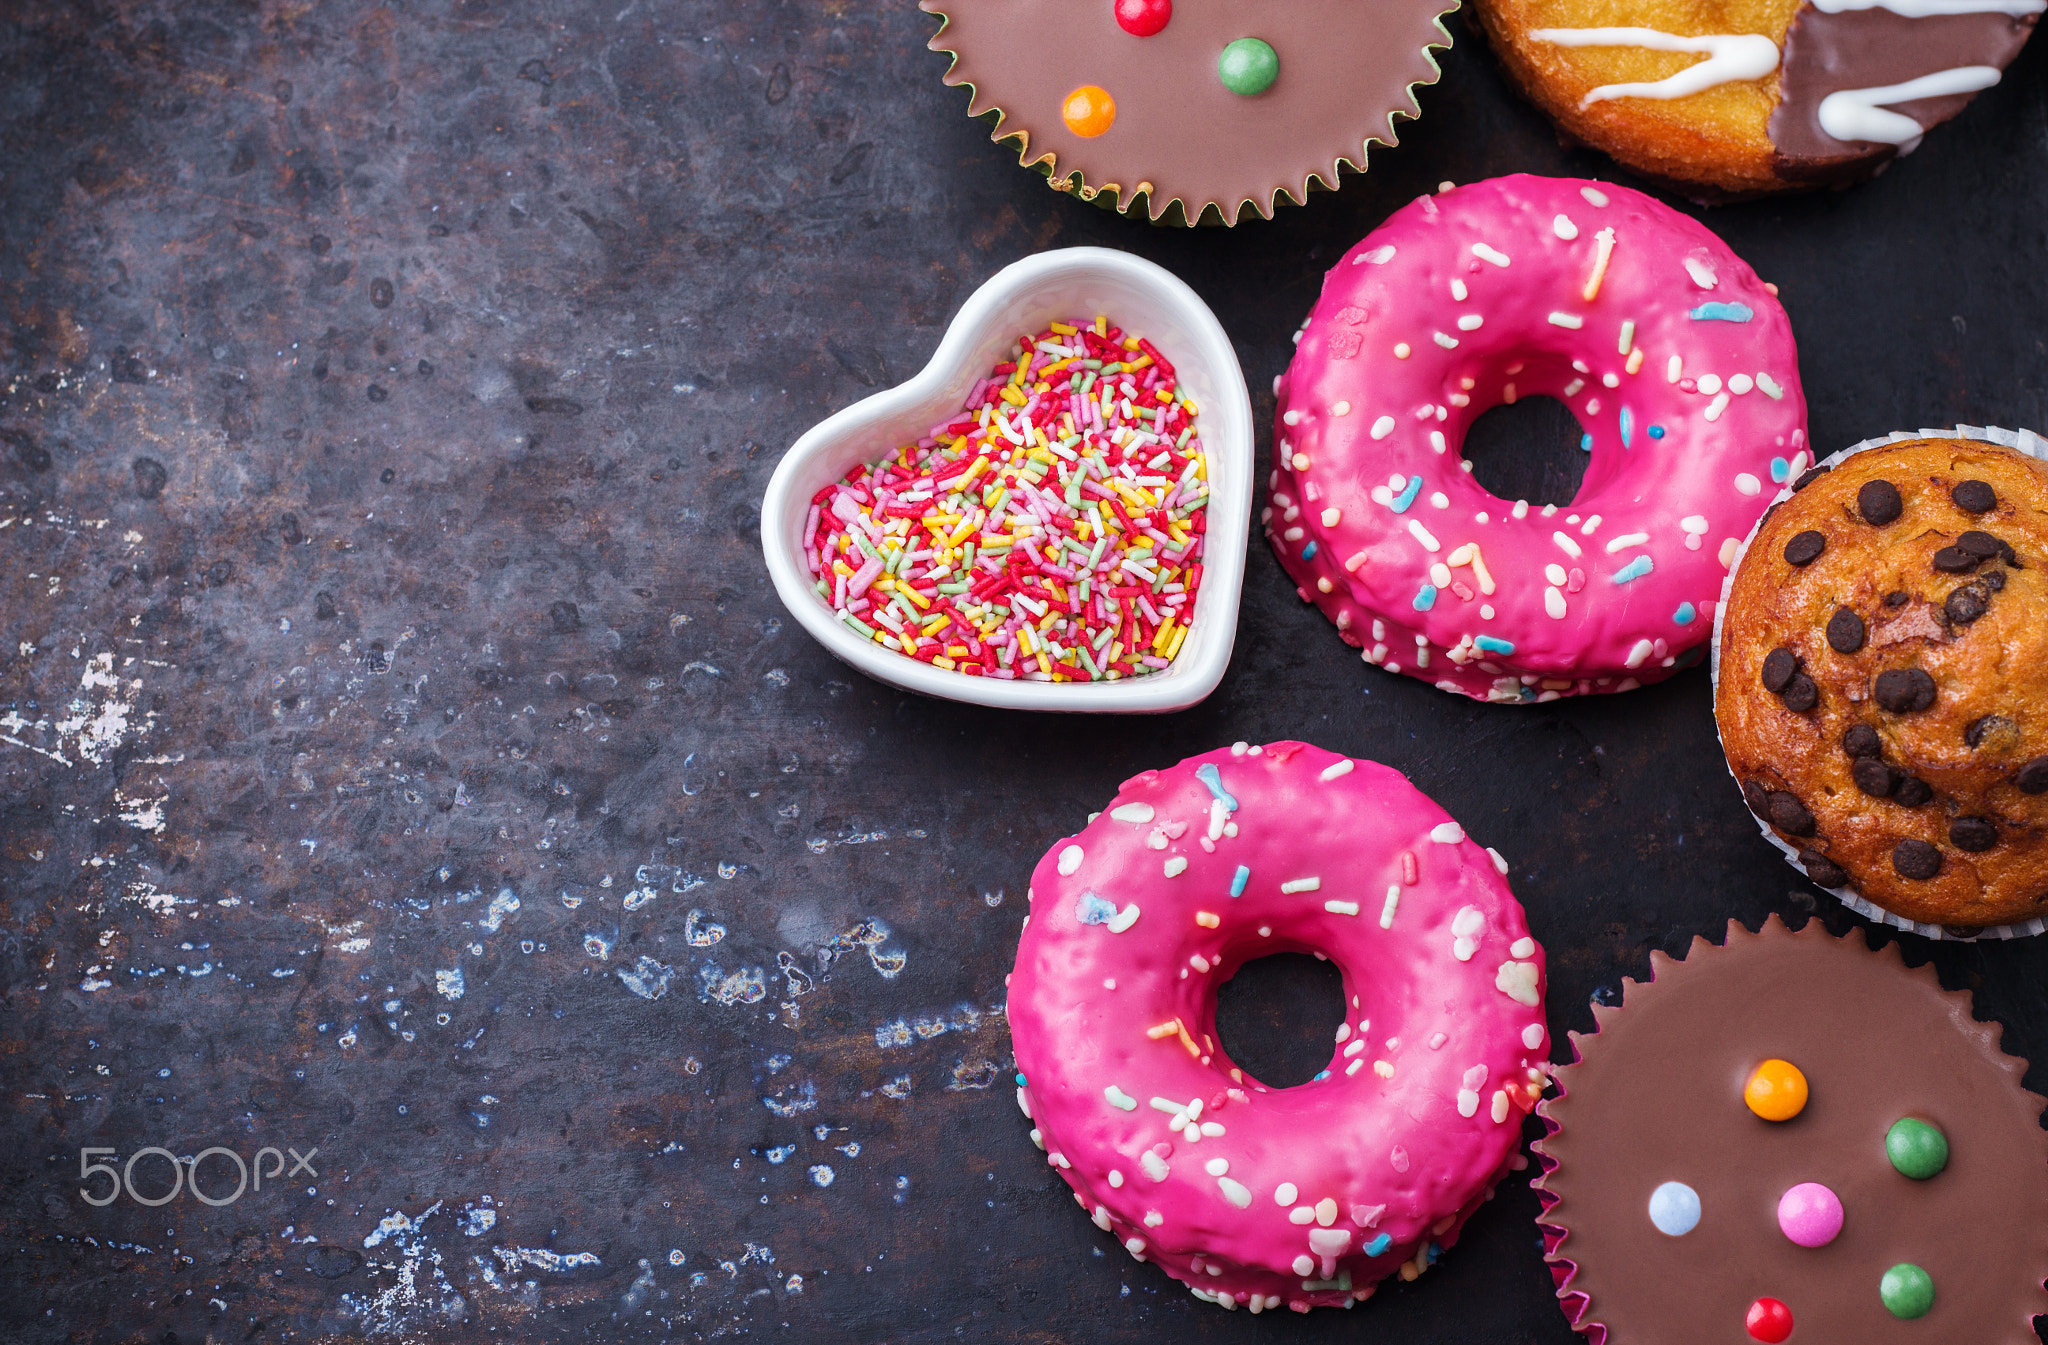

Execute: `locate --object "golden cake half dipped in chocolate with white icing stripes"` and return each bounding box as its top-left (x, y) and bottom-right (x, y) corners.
top-left (1477, 0), bottom-right (2044, 199)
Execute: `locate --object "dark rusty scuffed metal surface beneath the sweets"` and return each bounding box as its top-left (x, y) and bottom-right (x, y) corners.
top-left (0, 0), bottom-right (2048, 1345)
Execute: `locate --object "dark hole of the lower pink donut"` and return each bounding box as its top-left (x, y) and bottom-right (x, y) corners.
top-left (1217, 952), bottom-right (1343, 1089)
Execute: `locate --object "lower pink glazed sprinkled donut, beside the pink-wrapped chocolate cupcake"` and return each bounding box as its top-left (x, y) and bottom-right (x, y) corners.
top-left (1008, 743), bottom-right (1546, 1312)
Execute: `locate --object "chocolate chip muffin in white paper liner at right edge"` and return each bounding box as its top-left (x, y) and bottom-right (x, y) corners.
top-left (1714, 438), bottom-right (2048, 931)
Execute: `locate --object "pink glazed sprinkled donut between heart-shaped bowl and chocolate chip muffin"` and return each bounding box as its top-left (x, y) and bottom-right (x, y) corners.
top-left (1264, 176), bottom-right (1810, 702)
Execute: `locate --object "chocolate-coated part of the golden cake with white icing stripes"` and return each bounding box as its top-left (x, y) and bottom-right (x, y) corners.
top-left (1769, 4), bottom-right (2036, 180)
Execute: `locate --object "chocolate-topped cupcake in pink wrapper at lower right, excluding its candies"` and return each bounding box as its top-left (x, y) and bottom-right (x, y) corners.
top-left (1536, 917), bottom-right (2048, 1345)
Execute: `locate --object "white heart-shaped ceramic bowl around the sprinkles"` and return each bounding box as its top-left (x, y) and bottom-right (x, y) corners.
top-left (762, 248), bottom-right (1251, 714)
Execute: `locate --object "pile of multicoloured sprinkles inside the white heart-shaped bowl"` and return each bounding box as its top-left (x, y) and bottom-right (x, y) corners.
top-left (803, 317), bottom-right (1208, 682)
